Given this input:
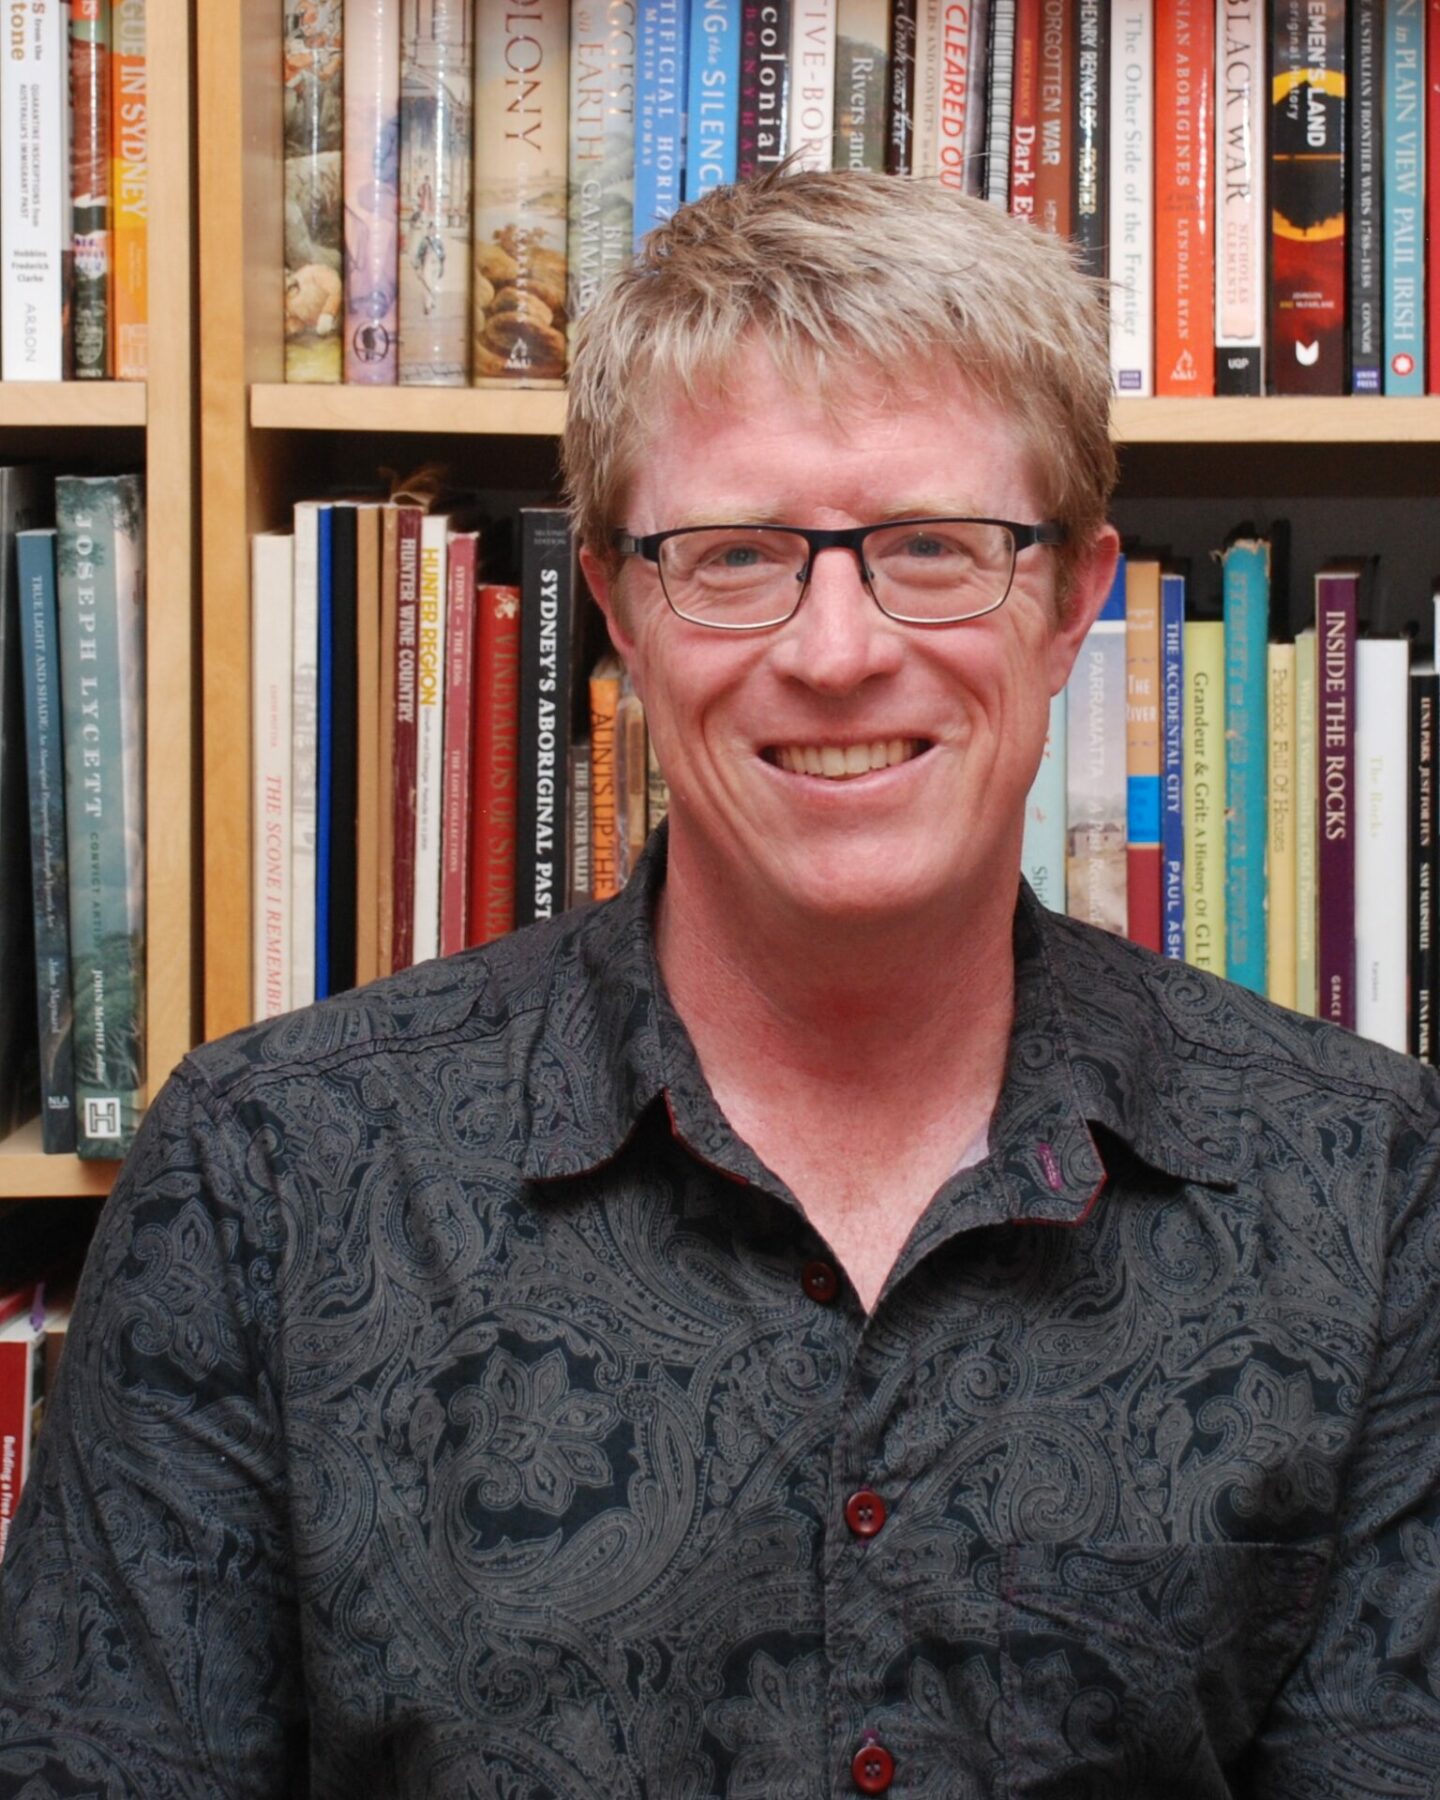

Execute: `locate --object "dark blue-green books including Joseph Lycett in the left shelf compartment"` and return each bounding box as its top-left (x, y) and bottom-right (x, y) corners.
top-left (0, 466), bottom-right (146, 1159)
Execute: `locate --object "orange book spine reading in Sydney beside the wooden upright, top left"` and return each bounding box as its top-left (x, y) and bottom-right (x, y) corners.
top-left (110, 0), bottom-right (149, 382)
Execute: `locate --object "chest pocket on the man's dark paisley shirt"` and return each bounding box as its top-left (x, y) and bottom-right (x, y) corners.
top-left (1001, 1543), bottom-right (1330, 1800)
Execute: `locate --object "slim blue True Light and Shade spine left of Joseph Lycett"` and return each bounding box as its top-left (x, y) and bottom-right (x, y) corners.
top-left (16, 531), bottom-right (76, 1156)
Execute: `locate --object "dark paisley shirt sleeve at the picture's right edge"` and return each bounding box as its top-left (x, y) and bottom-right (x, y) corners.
top-left (1238, 1134), bottom-right (1440, 1800)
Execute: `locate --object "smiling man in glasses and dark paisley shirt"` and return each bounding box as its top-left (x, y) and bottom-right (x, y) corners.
top-left (0, 175), bottom-right (1440, 1800)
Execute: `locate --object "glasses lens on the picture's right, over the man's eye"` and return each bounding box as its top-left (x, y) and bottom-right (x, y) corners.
top-left (866, 518), bottom-right (1015, 623)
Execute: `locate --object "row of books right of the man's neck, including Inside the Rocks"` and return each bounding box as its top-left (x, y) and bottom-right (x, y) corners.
top-left (1044, 533), bottom-right (1440, 1062)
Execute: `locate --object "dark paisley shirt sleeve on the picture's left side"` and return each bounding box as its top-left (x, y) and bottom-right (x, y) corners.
top-left (0, 1071), bottom-right (304, 1800)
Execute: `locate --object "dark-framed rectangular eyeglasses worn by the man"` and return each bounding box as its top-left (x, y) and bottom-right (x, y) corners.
top-left (614, 518), bottom-right (1066, 632)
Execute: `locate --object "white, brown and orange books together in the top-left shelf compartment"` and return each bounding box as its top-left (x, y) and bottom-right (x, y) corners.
top-left (0, 0), bottom-right (149, 382)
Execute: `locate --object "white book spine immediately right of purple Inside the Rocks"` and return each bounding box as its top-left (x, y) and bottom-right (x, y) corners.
top-left (1355, 637), bottom-right (1409, 1051)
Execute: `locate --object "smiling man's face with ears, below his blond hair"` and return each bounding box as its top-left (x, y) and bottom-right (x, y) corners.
top-left (585, 349), bottom-right (1114, 925)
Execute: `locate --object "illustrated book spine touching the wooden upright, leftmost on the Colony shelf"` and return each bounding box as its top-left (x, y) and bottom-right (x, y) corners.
top-left (284, 0), bottom-right (346, 382)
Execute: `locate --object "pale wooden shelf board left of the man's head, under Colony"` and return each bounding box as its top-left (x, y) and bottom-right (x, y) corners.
top-left (250, 382), bottom-right (565, 437)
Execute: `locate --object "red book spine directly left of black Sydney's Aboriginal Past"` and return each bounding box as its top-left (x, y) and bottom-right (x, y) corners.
top-left (466, 585), bottom-right (520, 943)
